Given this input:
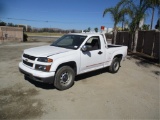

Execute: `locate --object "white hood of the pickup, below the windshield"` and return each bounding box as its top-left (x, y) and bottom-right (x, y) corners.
top-left (24, 46), bottom-right (72, 57)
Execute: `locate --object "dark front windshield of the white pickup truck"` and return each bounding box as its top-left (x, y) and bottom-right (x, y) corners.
top-left (51, 35), bottom-right (87, 49)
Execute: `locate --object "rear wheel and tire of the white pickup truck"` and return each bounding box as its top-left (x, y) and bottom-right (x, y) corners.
top-left (109, 57), bottom-right (120, 73)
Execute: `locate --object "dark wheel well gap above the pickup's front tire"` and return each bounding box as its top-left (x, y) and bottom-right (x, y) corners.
top-left (56, 61), bottom-right (77, 74)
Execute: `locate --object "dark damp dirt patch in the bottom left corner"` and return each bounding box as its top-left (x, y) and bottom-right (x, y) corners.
top-left (0, 84), bottom-right (43, 119)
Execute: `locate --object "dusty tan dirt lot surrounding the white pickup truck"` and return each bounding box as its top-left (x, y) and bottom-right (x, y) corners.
top-left (0, 42), bottom-right (160, 119)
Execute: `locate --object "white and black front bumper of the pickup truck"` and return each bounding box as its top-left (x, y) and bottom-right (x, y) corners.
top-left (19, 62), bottom-right (55, 83)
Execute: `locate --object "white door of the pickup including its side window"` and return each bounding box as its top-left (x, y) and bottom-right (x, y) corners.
top-left (80, 36), bottom-right (105, 73)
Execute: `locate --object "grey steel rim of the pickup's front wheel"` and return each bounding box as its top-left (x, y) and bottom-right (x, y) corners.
top-left (60, 71), bottom-right (72, 86)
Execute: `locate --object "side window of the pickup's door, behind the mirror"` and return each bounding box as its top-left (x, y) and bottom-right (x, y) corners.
top-left (85, 36), bottom-right (101, 50)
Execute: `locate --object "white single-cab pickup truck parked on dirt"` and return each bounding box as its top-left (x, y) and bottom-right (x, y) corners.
top-left (19, 33), bottom-right (127, 90)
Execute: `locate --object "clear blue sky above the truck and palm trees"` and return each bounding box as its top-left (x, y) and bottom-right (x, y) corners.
top-left (0, 0), bottom-right (158, 29)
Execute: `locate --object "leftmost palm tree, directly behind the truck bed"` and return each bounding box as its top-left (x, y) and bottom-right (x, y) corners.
top-left (103, 0), bottom-right (130, 44)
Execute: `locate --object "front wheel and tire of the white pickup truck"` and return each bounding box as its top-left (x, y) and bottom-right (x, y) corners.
top-left (54, 66), bottom-right (75, 90)
